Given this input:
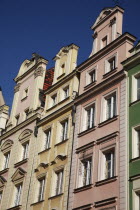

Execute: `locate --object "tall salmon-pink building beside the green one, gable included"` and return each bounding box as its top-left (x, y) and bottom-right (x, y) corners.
top-left (68, 6), bottom-right (135, 210)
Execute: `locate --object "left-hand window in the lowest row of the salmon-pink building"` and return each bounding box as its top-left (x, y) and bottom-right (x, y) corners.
top-left (78, 158), bottom-right (92, 187)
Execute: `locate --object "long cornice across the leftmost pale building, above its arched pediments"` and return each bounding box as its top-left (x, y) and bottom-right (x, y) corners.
top-left (0, 113), bottom-right (41, 141)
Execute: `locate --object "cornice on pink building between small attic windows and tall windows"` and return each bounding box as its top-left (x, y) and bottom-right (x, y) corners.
top-left (74, 70), bottom-right (126, 104)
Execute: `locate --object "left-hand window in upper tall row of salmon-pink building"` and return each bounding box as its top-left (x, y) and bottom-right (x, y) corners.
top-left (83, 104), bottom-right (95, 130)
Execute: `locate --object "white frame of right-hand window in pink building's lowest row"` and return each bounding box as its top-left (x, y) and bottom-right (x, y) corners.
top-left (98, 145), bottom-right (116, 181)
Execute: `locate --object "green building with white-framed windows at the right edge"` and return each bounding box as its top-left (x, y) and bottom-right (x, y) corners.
top-left (122, 43), bottom-right (140, 210)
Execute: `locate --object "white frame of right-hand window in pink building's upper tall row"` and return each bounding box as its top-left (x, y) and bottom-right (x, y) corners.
top-left (100, 90), bottom-right (118, 122)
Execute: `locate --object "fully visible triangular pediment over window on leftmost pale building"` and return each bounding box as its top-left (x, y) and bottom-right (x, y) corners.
top-left (11, 167), bottom-right (26, 182)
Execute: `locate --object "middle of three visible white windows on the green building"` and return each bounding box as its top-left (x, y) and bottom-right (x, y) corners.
top-left (132, 127), bottom-right (140, 158)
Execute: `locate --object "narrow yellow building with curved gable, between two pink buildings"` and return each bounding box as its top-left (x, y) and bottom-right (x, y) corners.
top-left (31, 44), bottom-right (79, 210)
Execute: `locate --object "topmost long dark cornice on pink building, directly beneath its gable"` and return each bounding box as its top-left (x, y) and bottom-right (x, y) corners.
top-left (76, 32), bottom-right (136, 71)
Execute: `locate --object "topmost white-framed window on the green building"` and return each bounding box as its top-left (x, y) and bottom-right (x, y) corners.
top-left (131, 72), bottom-right (140, 102)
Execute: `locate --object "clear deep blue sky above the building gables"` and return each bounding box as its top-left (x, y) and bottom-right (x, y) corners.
top-left (0, 0), bottom-right (140, 106)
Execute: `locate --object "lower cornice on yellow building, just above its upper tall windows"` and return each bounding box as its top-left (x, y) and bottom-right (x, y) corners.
top-left (37, 101), bottom-right (74, 127)
